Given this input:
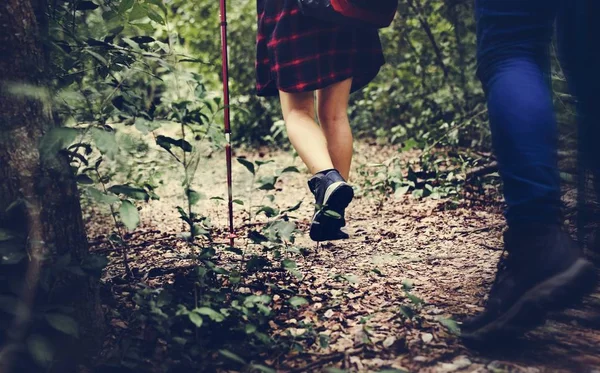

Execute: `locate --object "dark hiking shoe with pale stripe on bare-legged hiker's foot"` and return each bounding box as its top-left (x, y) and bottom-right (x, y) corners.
top-left (308, 170), bottom-right (354, 242)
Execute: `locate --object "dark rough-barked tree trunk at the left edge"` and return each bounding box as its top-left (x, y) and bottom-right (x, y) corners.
top-left (0, 0), bottom-right (104, 372)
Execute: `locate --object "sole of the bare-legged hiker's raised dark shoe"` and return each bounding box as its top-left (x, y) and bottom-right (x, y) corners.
top-left (310, 182), bottom-right (354, 242)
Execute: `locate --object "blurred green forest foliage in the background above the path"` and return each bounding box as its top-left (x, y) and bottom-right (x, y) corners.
top-left (44, 0), bottom-right (488, 146)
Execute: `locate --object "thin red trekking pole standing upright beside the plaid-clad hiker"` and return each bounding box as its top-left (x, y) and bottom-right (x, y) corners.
top-left (220, 0), bottom-right (235, 247)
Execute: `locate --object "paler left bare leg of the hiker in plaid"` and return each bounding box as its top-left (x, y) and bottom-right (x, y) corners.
top-left (279, 91), bottom-right (334, 174)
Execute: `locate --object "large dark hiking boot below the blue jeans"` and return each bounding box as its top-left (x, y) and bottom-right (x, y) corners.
top-left (462, 225), bottom-right (596, 342)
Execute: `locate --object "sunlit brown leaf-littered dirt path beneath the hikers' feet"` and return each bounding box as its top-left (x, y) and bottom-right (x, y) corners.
top-left (90, 143), bottom-right (600, 373)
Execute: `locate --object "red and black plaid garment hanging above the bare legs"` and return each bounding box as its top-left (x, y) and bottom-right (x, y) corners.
top-left (256, 0), bottom-right (384, 96)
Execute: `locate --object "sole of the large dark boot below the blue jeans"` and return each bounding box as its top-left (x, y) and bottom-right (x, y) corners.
top-left (462, 259), bottom-right (597, 342)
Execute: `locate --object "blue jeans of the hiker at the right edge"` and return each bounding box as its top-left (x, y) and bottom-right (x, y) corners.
top-left (475, 0), bottom-right (600, 225)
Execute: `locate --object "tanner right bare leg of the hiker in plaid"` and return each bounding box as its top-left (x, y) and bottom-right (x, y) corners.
top-left (317, 79), bottom-right (353, 180)
